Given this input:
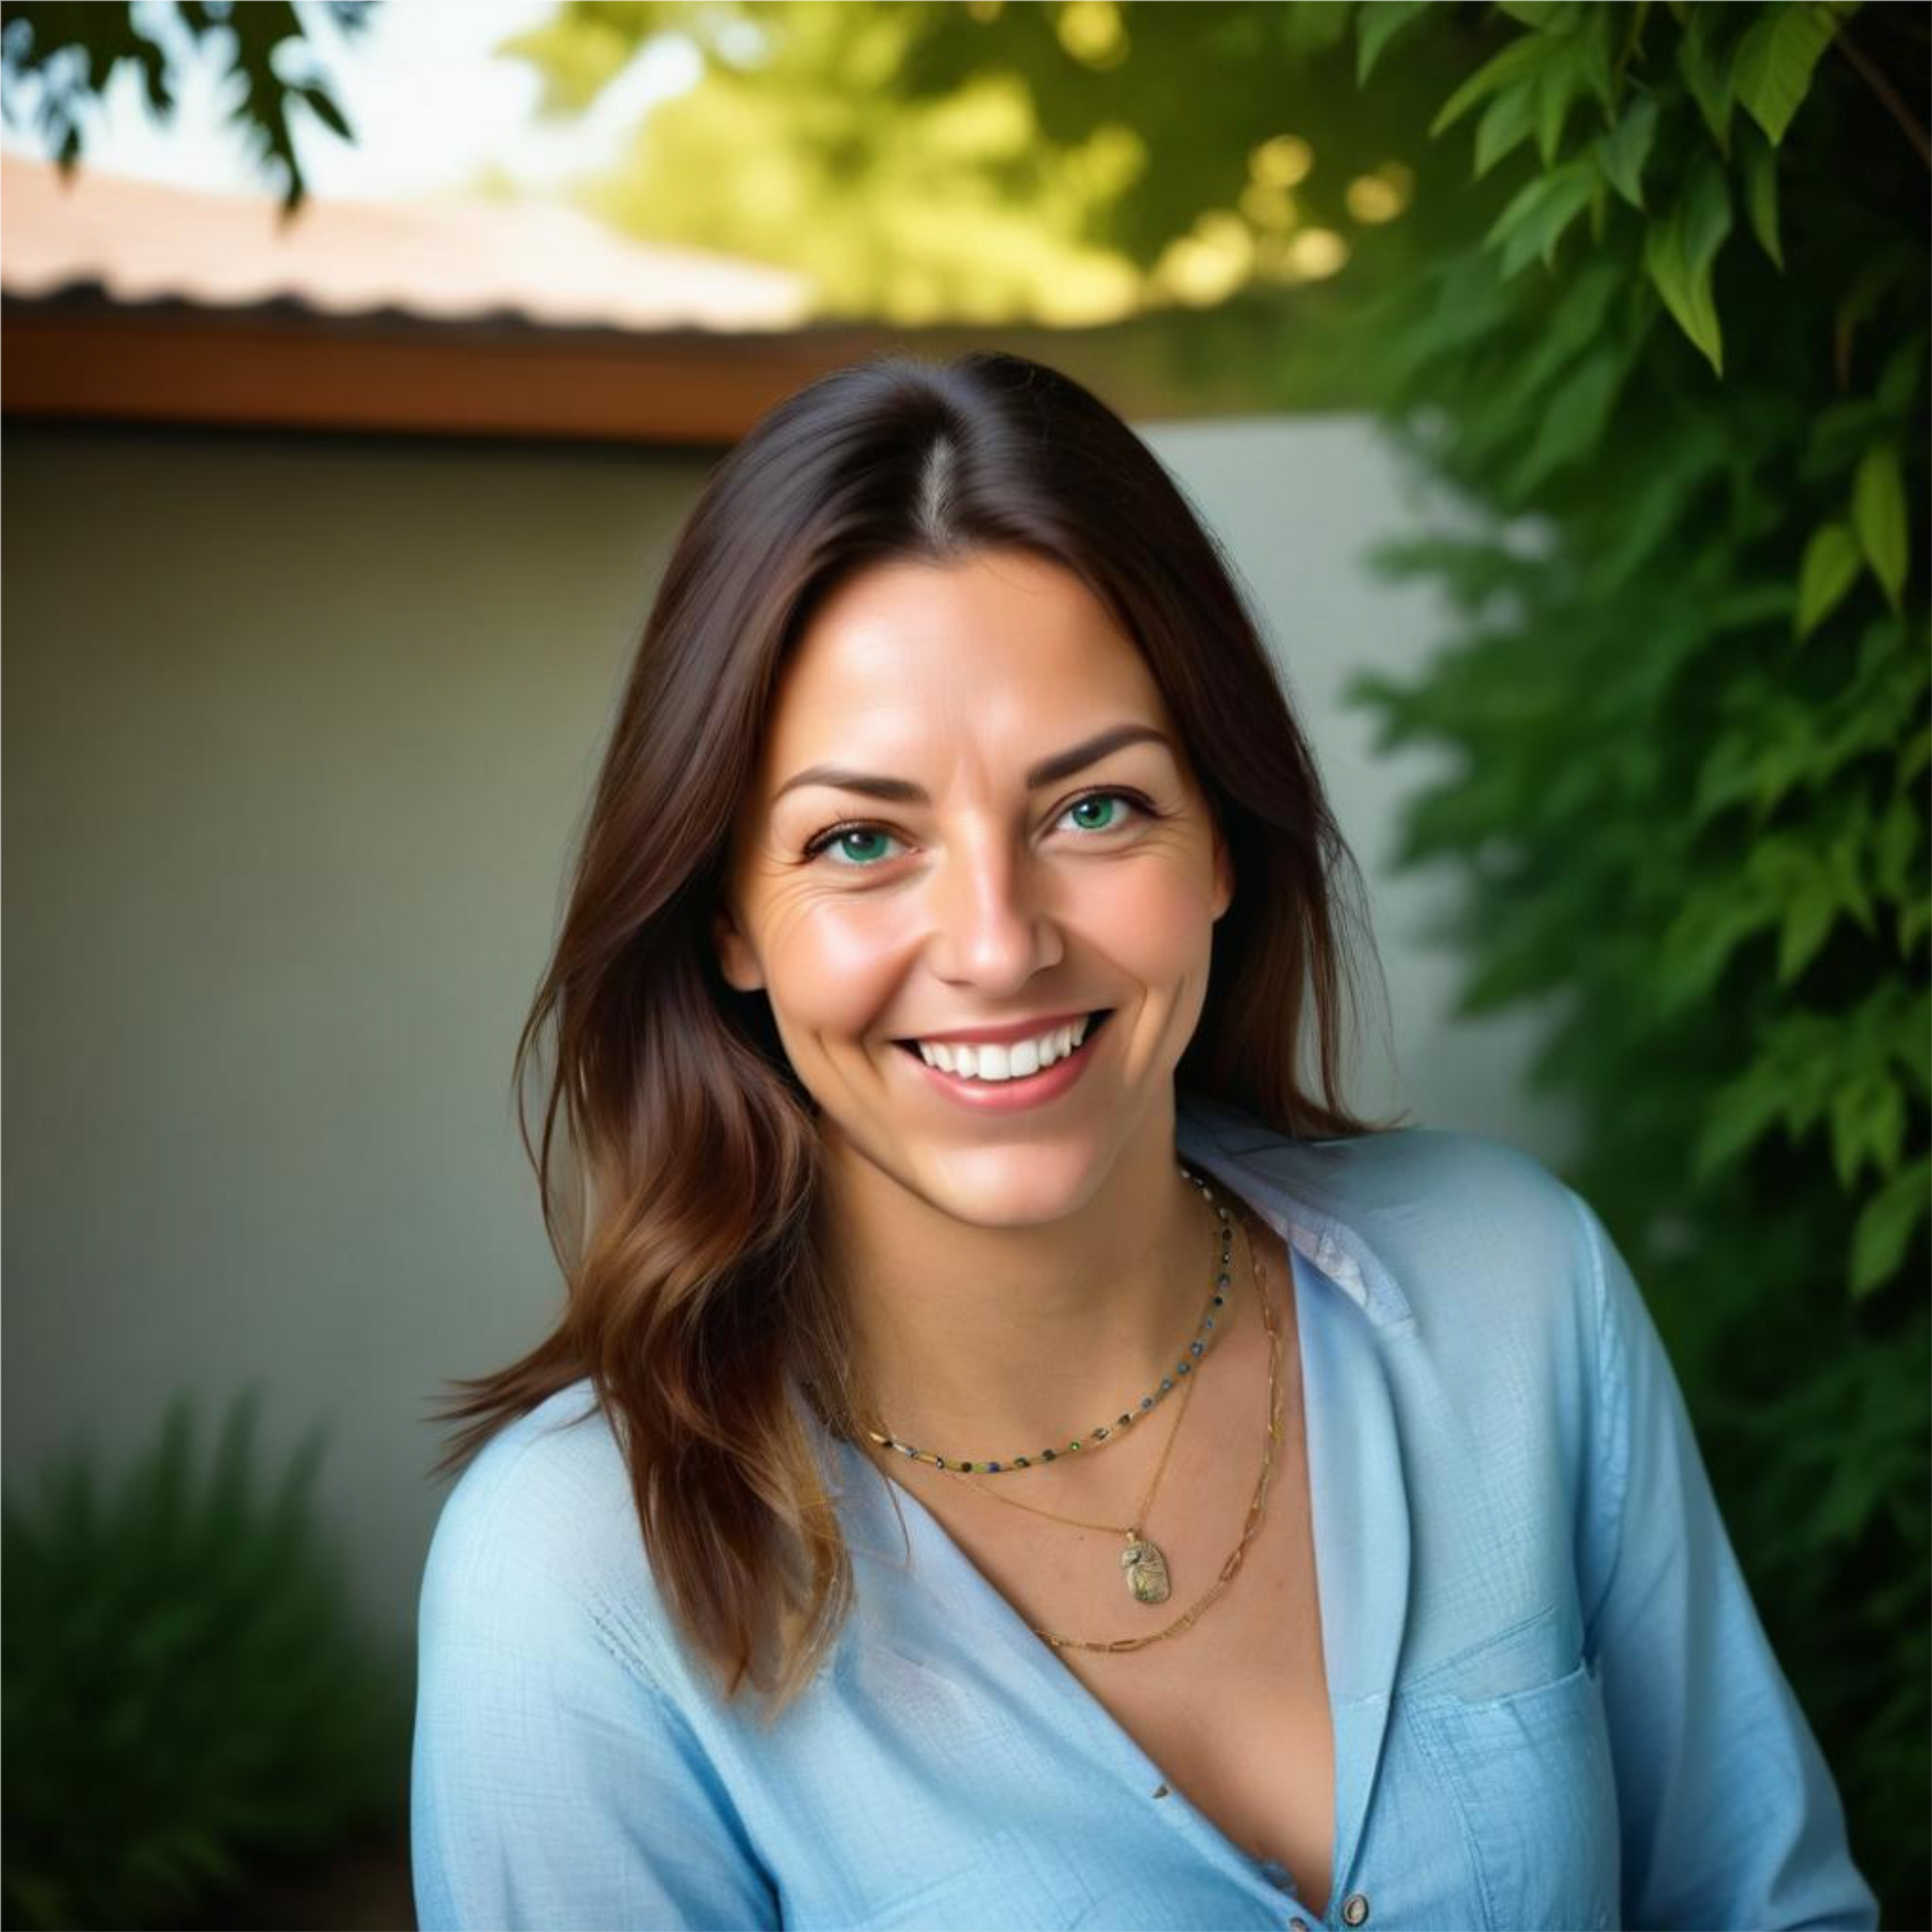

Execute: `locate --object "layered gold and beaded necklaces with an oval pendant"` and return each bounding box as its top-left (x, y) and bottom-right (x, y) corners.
top-left (866, 1167), bottom-right (1281, 1652)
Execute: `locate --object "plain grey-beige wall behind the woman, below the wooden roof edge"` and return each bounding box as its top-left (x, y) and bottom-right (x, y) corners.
top-left (0, 407), bottom-right (1561, 1632)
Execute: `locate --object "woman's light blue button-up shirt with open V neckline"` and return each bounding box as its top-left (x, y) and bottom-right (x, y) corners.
top-left (411, 1093), bottom-right (1878, 1932)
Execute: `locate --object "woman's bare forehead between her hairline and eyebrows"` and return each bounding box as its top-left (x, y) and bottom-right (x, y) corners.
top-left (765, 551), bottom-right (1167, 776)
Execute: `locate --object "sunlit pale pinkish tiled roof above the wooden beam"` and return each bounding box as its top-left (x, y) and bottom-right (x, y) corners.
top-left (0, 155), bottom-right (809, 333)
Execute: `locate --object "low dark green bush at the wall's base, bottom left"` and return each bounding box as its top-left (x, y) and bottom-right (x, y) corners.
top-left (0, 1395), bottom-right (410, 1932)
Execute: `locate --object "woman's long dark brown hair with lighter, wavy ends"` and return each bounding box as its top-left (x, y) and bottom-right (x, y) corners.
top-left (439, 351), bottom-right (1401, 1716)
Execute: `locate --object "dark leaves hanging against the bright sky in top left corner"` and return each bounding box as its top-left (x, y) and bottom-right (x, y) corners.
top-left (0, 0), bottom-right (376, 210)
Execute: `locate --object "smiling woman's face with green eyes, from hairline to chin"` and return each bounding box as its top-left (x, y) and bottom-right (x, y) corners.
top-left (717, 551), bottom-right (1233, 1225)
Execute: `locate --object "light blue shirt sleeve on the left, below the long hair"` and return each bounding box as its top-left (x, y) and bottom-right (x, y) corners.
top-left (410, 1450), bottom-right (778, 1932)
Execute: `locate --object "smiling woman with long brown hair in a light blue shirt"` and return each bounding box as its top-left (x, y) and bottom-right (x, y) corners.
top-left (413, 353), bottom-right (1876, 1932)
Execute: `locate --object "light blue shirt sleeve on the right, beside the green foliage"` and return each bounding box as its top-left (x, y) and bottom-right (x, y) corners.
top-left (1565, 1190), bottom-right (1878, 1932)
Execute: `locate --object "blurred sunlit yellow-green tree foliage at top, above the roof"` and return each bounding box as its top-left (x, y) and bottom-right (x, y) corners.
top-left (504, 0), bottom-right (1452, 325)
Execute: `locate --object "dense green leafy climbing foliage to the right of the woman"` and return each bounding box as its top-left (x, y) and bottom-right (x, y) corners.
top-left (1328, 0), bottom-right (1932, 1922)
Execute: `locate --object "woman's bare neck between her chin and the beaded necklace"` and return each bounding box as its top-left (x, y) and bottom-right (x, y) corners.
top-left (823, 1132), bottom-right (1221, 1458)
